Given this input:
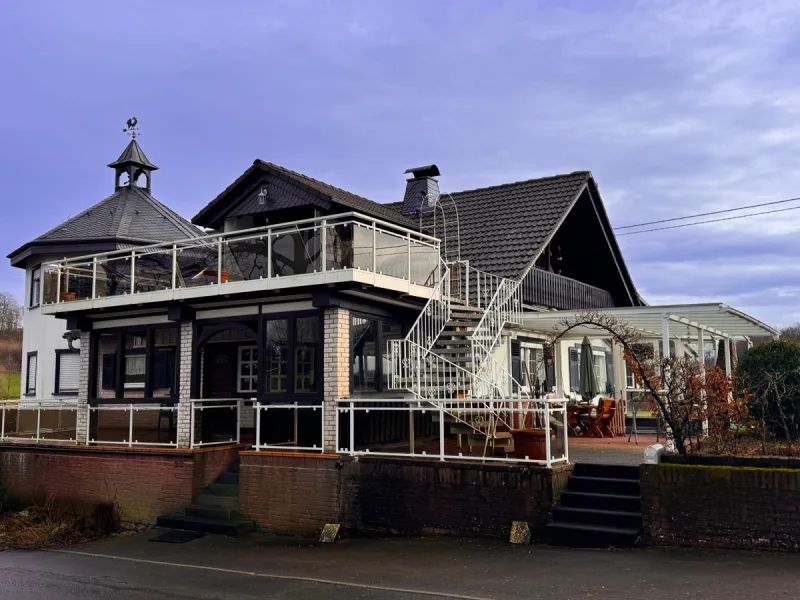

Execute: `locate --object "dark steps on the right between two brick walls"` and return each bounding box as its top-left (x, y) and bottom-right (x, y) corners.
top-left (547, 463), bottom-right (642, 548)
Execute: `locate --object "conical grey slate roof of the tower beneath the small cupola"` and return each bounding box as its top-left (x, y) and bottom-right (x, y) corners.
top-left (9, 186), bottom-right (202, 258)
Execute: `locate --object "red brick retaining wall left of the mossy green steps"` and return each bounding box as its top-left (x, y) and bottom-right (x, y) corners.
top-left (0, 446), bottom-right (238, 523)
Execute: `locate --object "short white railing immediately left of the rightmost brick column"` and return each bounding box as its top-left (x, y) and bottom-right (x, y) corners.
top-left (253, 402), bottom-right (325, 452)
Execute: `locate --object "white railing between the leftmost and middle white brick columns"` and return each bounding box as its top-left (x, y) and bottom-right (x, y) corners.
top-left (86, 404), bottom-right (178, 448)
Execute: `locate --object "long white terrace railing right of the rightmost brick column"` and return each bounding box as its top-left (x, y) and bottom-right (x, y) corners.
top-left (336, 398), bottom-right (569, 467)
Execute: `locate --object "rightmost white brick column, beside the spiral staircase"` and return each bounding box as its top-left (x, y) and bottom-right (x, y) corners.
top-left (322, 308), bottom-right (350, 453)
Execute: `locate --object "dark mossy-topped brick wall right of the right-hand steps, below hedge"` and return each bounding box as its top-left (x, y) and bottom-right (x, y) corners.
top-left (641, 463), bottom-right (800, 551)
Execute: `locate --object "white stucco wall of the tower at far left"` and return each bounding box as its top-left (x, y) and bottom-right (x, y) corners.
top-left (20, 256), bottom-right (79, 401)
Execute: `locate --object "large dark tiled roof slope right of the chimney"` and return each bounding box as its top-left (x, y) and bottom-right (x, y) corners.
top-left (428, 171), bottom-right (592, 279)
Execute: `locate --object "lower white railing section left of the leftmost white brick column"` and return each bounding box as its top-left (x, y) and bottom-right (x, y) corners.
top-left (0, 400), bottom-right (78, 444)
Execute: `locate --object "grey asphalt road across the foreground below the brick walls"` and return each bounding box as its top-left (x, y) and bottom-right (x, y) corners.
top-left (0, 532), bottom-right (800, 600)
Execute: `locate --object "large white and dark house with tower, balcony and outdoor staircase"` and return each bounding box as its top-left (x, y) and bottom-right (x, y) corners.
top-left (0, 131), bottom-right (774, 536)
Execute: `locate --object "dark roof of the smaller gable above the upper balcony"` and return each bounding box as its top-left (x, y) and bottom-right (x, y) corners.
top-left (192, 160), bottom-right (419, 228)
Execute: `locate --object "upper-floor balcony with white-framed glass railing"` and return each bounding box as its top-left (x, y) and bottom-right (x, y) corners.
top-left (42, 213), bottom-right (440, 314)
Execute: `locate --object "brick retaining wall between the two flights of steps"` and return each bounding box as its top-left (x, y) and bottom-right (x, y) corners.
top-left (239, 452), bottom-right (570, 537)
